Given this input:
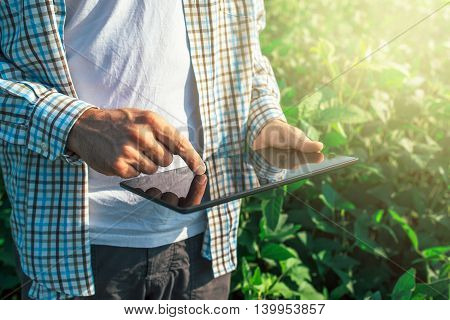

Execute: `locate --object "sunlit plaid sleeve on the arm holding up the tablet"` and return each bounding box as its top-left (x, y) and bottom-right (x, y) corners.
top-left (247, 0), bottom-right (287, 147)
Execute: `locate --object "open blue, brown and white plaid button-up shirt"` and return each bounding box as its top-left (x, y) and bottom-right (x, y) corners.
top-left (0, 0), bottom-right (284, 299)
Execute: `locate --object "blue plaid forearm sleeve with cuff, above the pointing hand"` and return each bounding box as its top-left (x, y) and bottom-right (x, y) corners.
top-left (0, 55), bottom-right (94, 164)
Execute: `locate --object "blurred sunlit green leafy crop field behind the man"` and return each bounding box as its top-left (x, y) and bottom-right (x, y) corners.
top-left (0, 0), bottom-right (450, 299)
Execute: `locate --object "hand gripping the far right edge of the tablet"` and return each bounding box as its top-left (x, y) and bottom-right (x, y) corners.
top-left (252, 119), bottom-right (323, 152)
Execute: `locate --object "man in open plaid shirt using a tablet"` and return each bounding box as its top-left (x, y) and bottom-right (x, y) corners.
top-left (0, 0), bottom-right (322, 299)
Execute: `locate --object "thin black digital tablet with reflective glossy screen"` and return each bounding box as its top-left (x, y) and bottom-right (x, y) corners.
top-left (120, 148), bottom-right (358, 213)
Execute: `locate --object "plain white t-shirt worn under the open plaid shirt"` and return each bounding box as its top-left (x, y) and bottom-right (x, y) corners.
top-left (64, 0), bottom-right (206, 248)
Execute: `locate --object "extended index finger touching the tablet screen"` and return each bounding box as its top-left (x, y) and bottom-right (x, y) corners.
top-left (154, 117), bottom-right (206, 175)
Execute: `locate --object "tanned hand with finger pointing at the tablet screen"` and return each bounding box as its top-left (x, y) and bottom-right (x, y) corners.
top-left (67, 108), bottom-right (206, 178)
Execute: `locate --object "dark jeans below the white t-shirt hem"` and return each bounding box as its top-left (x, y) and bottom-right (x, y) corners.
top-left (14, 234), bottom-right (231, 300)
